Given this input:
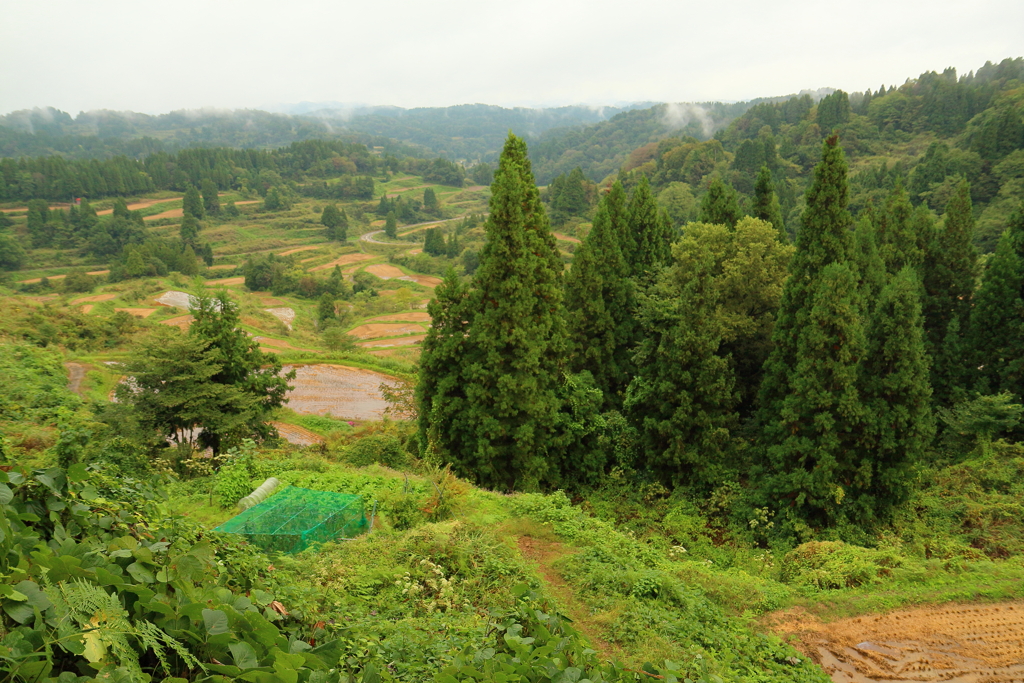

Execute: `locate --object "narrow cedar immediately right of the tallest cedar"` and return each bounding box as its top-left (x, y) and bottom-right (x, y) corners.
top-left (565, 195), bottom-right (635, 411)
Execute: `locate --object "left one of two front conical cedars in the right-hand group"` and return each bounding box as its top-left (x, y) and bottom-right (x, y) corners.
top-left (766, 264), bottom-right (871, 527)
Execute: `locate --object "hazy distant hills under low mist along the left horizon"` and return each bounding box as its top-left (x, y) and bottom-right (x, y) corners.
top-left (0, 102), bottom-right (649, 163)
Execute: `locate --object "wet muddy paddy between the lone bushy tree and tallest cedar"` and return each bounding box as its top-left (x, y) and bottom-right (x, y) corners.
top-left (282, 365), bottom-right (396, 421)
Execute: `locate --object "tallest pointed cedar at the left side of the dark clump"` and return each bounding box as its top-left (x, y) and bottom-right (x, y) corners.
top-left (449, 133), bottom-right (565, 489)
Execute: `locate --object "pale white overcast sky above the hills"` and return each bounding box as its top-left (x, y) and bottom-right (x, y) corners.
top-left (0, 0), bottom-right (1024, 115)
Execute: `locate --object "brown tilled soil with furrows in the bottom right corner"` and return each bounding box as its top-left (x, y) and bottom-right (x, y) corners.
top-left (769, 601), bottom-right (1024, 683)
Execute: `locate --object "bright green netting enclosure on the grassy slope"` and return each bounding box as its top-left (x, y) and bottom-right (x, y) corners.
top-left (215, 486), bottom-right (367, 553)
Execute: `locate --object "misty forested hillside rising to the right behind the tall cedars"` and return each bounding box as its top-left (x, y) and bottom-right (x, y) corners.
top-left (589, 57), bottom-right (1024, 252)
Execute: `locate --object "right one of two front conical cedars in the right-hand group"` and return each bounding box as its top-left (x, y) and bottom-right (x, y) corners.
top-left (845, 266), bottom-right (935, 523)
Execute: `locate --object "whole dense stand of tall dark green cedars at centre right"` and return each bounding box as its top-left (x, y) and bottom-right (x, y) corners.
top-left (418, 135), bottom-right (1024, 540)
